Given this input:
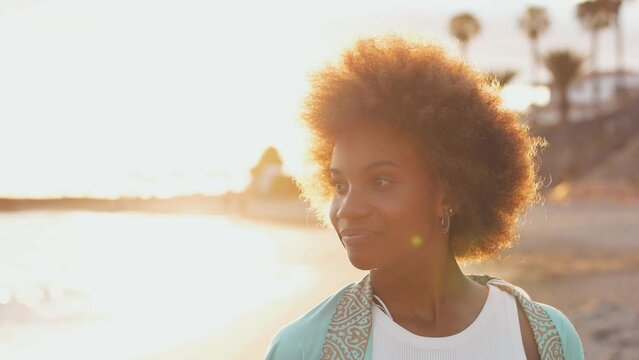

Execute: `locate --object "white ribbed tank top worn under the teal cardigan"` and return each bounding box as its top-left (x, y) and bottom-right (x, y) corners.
top-left (372, 284), bottom-right (526, 360)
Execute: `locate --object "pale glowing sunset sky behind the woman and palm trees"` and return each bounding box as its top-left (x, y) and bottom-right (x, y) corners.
top-left (0, 0), bottom-right (639, 197)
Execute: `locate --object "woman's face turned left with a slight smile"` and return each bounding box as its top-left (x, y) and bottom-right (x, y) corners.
top-left (330, 124), bottom-right (443, 270)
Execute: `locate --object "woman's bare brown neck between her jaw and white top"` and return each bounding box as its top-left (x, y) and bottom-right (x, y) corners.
top-left (370, 242), bottom-right (481, 323)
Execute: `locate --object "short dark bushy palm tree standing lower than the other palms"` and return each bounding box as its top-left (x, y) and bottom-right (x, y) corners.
top-left (544, 50), bottom-right (583, 124)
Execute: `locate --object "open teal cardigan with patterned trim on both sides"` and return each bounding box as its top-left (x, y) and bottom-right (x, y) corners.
top-left (266, 275), bottom-right (584, 360)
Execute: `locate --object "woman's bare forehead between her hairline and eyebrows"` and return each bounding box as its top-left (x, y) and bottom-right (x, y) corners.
top-left (331, 123), bottom-right (425, 171)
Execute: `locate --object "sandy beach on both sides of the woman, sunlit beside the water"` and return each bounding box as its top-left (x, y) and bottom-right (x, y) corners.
top-left (144, 203), bottom-right (639, 360)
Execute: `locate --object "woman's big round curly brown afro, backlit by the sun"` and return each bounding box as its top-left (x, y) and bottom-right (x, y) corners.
top-left (296, 35), bottom-right (545, 261)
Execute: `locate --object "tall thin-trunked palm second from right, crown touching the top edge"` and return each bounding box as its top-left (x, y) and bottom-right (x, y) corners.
top-left (577, 0), bottom-right (612, 101)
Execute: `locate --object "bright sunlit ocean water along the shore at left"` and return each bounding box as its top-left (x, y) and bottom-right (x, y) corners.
top-left (0, 212), bottom-right (320, 359)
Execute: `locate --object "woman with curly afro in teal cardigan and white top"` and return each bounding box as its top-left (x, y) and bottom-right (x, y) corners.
top-left (266, 36), bottom-right (583, 360)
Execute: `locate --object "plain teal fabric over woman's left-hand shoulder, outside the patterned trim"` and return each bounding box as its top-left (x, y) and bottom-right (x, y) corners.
top-left (266, 284), bottom-right (352, 360)
